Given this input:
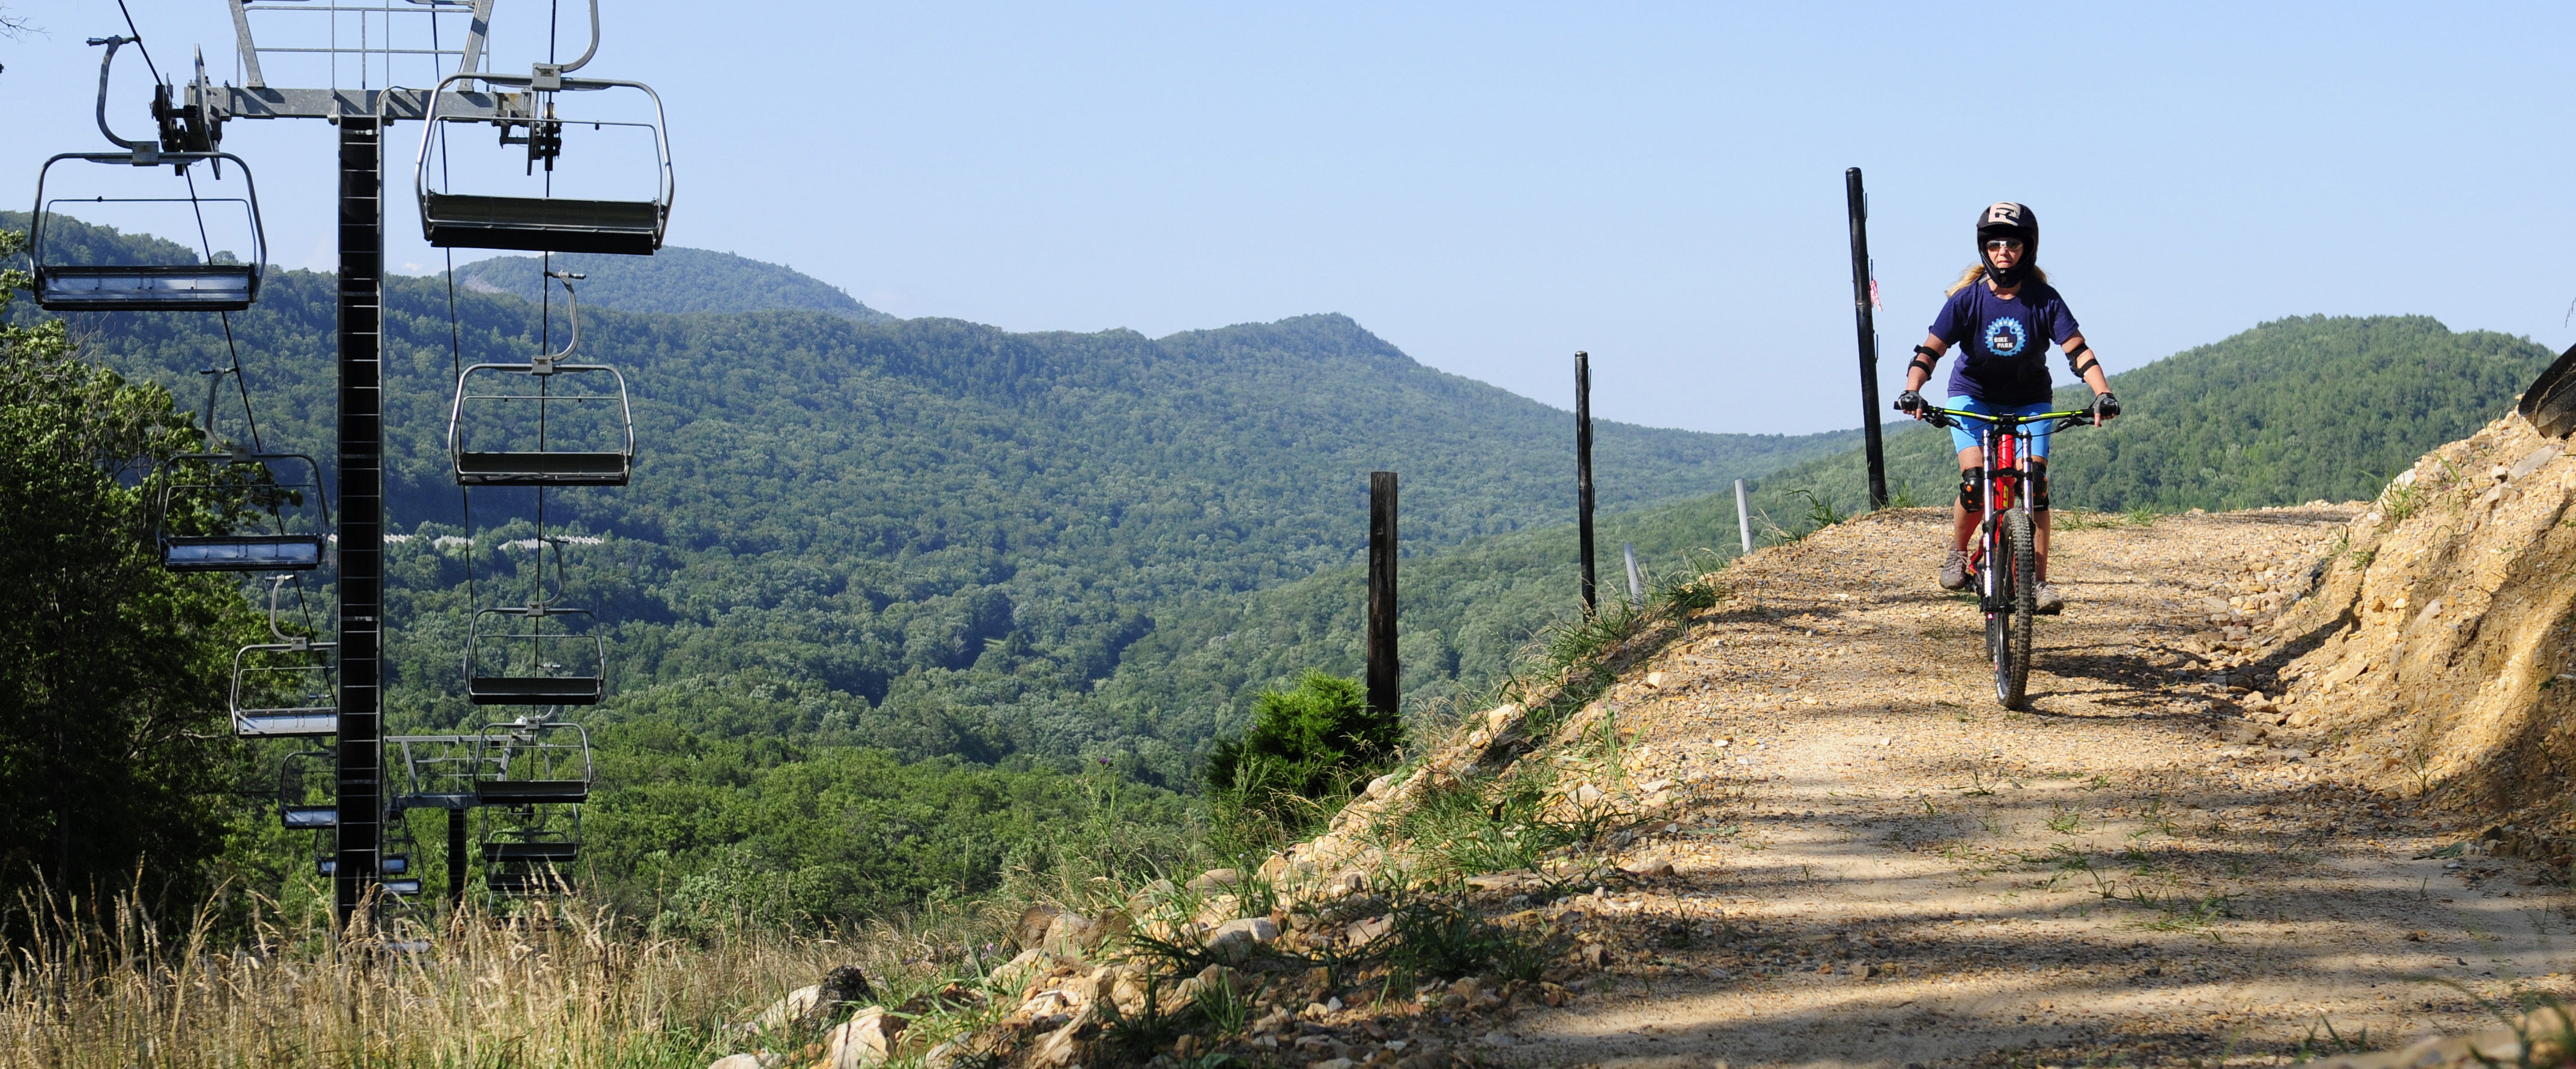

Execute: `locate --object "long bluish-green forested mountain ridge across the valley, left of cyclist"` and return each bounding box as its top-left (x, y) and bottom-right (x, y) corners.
top-left (10, 215), bottom-right (1855, 783)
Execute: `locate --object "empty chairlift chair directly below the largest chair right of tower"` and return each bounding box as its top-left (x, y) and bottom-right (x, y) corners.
top-left (448, 270), bottom-right (636, 487)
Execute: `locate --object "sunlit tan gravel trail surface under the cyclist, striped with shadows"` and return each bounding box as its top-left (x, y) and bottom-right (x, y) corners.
top-left (1481, 505), bottom-right (2571, 1067)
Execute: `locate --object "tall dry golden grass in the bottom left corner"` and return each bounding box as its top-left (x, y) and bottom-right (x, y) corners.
top-left (0, 886), bottom-right (1004, 1069)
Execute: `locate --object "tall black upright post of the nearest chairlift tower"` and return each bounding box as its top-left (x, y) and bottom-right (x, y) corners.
top-left (332, 116), bottom-right (384, 933)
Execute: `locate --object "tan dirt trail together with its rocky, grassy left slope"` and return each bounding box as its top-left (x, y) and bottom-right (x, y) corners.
top-left (690, 502), bottom-right (2571, 1069)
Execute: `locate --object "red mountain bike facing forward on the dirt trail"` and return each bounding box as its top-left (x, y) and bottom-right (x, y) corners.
top-left (1922, 404), bottom-right (2094, 708)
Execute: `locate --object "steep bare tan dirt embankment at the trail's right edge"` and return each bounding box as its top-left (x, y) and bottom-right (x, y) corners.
top-left (2282, 415), bottom-right (2576, 868)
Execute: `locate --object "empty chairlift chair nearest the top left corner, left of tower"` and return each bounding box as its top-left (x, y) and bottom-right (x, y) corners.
top-left (28, 144), bottom-right (268, 312)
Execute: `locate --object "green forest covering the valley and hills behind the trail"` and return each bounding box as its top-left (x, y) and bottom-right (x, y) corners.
top-left (15, 216), bottom-right (2548, 917)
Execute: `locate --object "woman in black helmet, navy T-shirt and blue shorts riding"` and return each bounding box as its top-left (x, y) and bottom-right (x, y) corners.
top-left (1896, 201), bottom-right (2120, 613)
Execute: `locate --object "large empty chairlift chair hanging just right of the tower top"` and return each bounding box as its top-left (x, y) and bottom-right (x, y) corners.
top-left (412, 2), bottom-right (672, 255)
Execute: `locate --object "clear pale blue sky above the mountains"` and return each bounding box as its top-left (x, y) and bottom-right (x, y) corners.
top-left (0, 0), bottom-right (2576, 433)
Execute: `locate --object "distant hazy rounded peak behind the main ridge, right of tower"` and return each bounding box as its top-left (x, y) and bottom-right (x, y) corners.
top-left (456, 248), bottom-right (894, 322)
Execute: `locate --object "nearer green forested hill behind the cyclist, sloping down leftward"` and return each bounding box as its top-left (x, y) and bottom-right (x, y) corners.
top-left (1100, 317), bottom-right (2553, 726)
